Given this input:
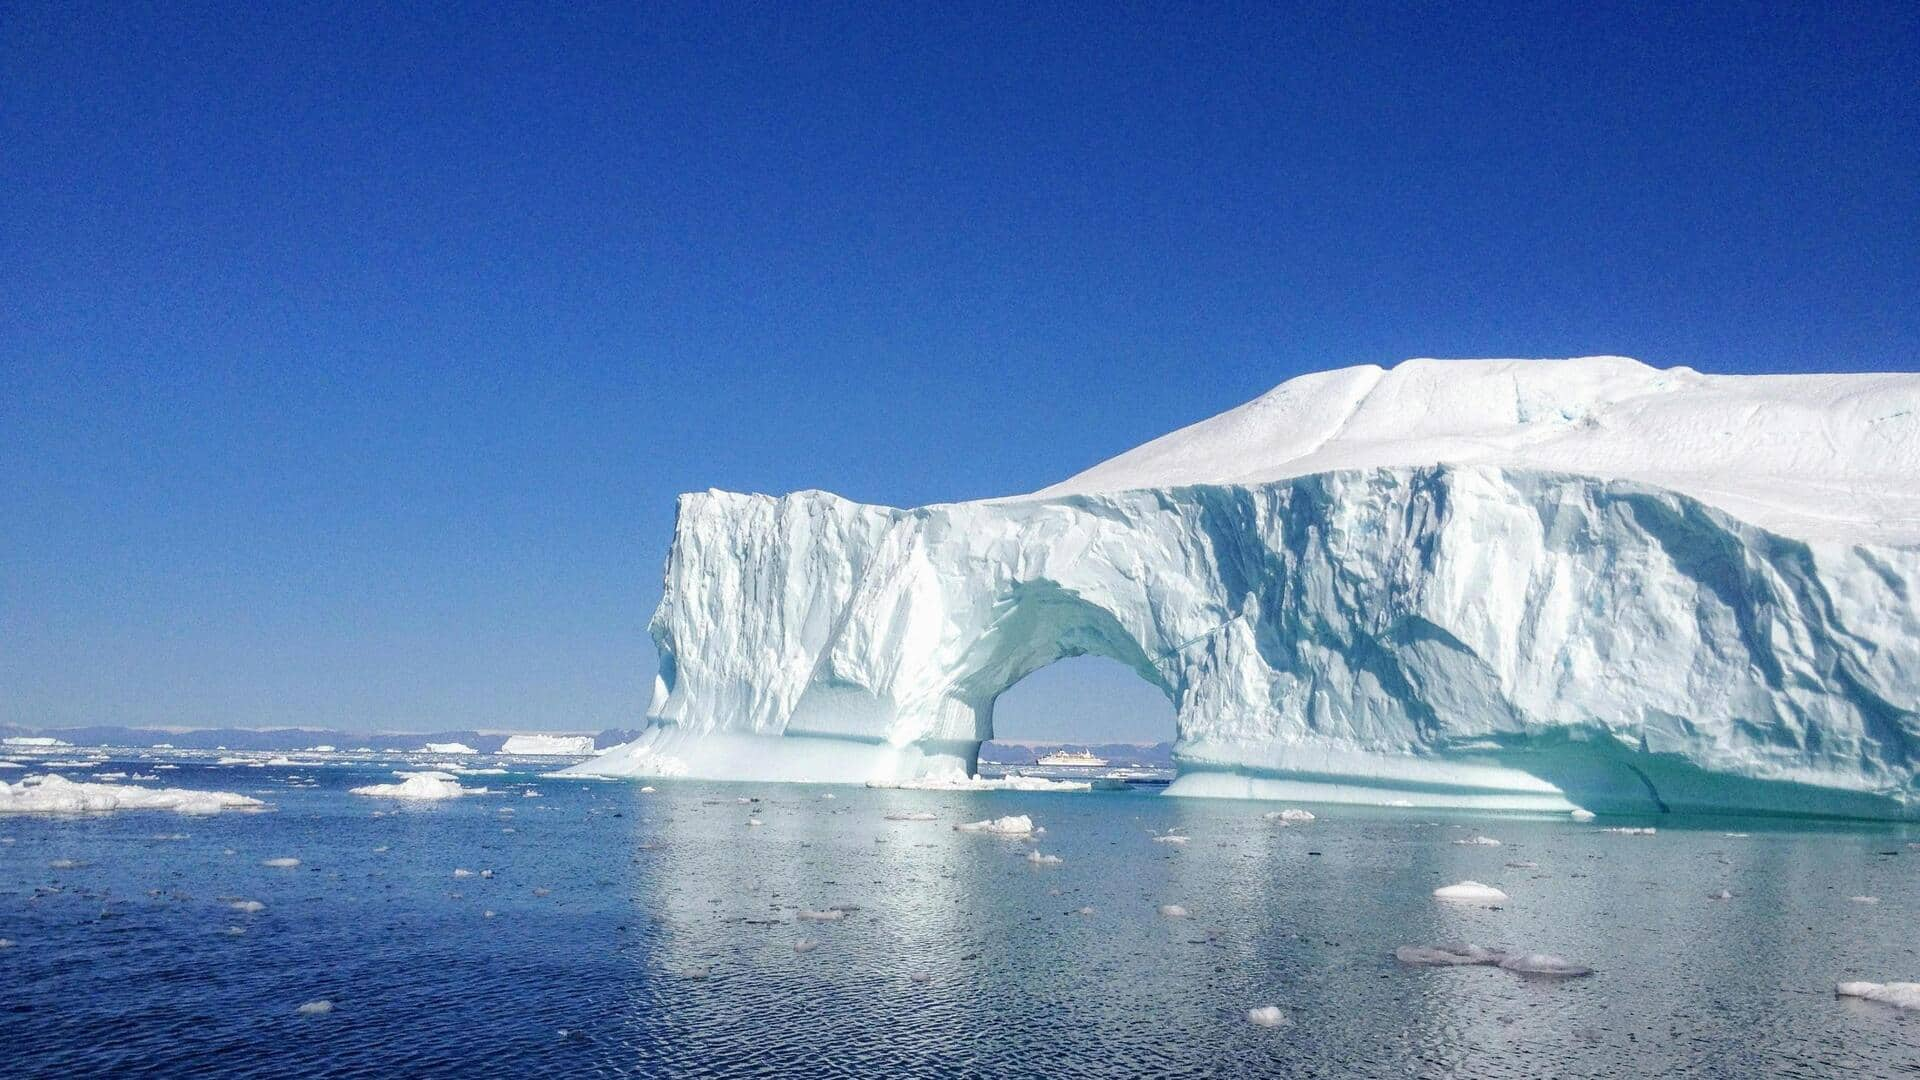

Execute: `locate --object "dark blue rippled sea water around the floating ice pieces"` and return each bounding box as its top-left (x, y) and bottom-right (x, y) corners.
top-left (0, 761), bottom-right (1920, 1078)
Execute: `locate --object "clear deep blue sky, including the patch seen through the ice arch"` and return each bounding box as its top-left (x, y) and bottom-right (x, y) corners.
top-left (0, 0), bottom-right (1920, 738)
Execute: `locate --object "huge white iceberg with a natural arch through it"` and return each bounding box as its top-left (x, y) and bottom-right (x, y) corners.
top-left (580, 357), bottom-right (1920, 817)
